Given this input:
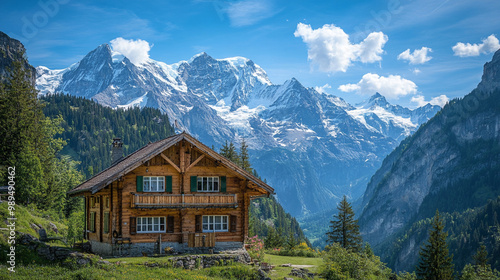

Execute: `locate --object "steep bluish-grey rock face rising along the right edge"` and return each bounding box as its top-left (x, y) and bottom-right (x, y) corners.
top-left (359, 50), bottom-right (500, 246)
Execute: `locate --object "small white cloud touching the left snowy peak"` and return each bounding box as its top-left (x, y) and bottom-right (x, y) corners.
top-left (111, 37), bottom-right (151, 65)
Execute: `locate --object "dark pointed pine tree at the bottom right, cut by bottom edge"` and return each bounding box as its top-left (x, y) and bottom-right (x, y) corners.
top-left (417, 210), bottom-right (454, 280)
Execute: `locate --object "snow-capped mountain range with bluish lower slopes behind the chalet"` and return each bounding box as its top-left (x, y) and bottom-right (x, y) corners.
top-left (37, 44), bottom-right (440, 216)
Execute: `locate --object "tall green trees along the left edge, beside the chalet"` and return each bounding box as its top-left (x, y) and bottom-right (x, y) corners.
top-left (0, 57), bottom-right (83, 216)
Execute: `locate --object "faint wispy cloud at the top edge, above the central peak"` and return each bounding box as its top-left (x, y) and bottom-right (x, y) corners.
top-left (225, 0), bottom-right (275, 27)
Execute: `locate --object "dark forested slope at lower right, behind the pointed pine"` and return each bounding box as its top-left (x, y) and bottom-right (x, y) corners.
top-left (377, 197), bottom-right (500, 271)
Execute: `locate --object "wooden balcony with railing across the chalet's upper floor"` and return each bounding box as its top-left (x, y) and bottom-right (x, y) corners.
top-left (131, 193), bottom-right (238, 208)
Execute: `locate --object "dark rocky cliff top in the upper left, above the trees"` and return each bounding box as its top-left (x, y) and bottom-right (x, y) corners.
top-left (0, 31), bottom-right (36, 84)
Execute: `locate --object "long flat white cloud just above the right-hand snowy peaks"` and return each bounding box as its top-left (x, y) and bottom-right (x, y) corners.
top-left (339, 73), bottom-right (417, 99)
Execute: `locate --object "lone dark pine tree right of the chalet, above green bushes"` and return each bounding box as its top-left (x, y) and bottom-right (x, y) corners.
top-left (327, 195), bottom-right (362, 252)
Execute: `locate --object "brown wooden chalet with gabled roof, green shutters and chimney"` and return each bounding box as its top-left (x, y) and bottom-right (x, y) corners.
top-left (69, 133), bottom-right (274, 255)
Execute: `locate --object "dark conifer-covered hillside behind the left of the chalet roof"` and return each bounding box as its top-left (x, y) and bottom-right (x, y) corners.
top-left (41, 94), bottom-right (174, 178)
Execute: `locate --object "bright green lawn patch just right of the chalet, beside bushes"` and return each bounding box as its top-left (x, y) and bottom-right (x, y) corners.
top-left (264, 254), bottom-right (323, 279)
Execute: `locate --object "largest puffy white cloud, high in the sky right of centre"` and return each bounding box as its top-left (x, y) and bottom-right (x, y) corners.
top-left (294, 23), bottom-right (388, 73)
